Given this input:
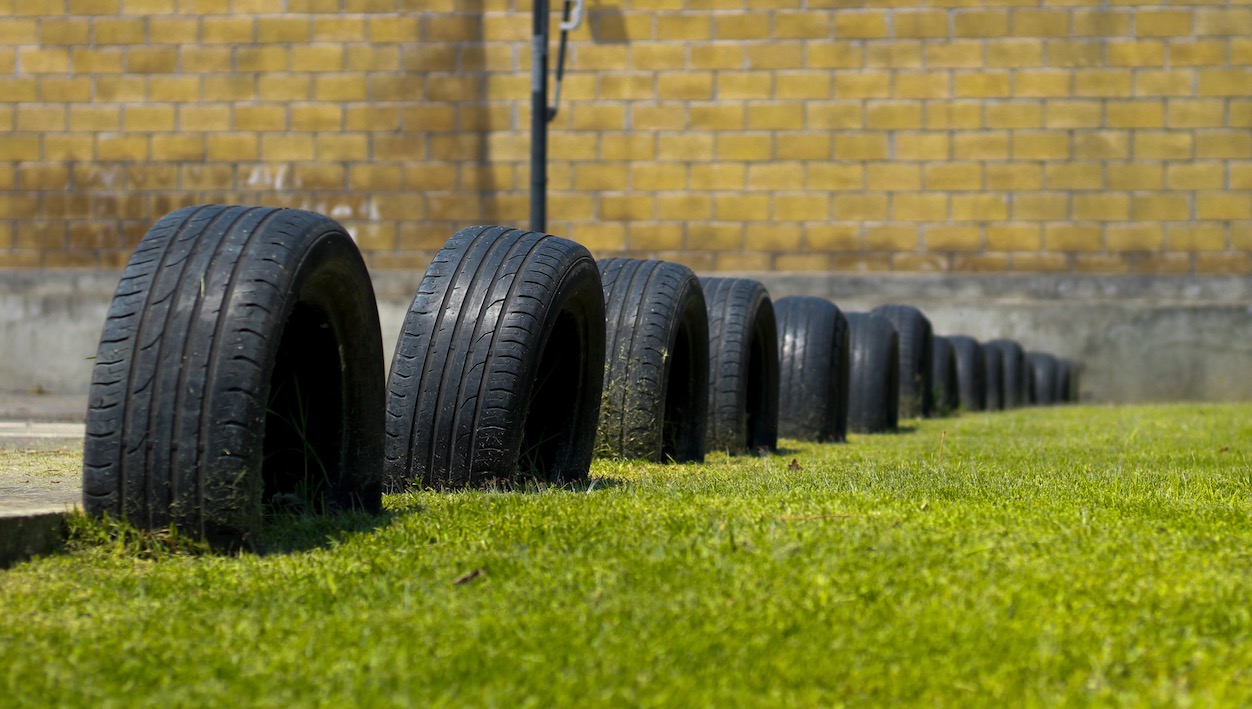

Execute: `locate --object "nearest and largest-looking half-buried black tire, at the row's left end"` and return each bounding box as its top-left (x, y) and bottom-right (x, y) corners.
top-left (83, 205), bottom-right (383, 549)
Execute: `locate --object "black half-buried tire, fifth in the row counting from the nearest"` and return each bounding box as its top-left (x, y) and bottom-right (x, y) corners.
top-left (774, 296), bottom-right (849, 442)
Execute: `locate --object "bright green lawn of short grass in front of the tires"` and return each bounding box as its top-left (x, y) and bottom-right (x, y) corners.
top-left (0, 405), bottom-right (1252, 706)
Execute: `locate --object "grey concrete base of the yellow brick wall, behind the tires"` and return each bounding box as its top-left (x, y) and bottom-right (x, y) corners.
top-left (0, 271), bottom-right (1252, 402)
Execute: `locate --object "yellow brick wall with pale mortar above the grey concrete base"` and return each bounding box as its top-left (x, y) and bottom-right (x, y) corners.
top-left (0, 0), bottom-right (1252, 273)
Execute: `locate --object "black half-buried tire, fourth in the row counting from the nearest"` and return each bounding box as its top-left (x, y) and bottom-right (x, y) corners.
top-left (700, 278), bottom-right (779, 455)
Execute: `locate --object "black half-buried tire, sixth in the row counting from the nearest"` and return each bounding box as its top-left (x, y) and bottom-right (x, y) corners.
top-left (846, 313), bottom-right (900, 433)
